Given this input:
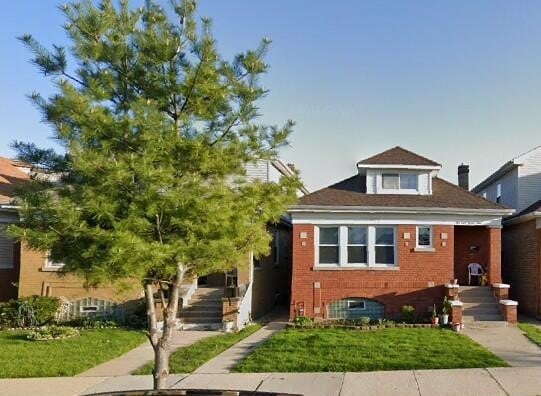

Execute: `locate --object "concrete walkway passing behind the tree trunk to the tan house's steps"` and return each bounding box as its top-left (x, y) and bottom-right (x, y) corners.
top-left (76, 331), bottom-right (222, 376)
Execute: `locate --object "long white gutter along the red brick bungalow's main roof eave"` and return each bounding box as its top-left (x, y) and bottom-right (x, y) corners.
top-left (288, 205), bottom-right (512, 216)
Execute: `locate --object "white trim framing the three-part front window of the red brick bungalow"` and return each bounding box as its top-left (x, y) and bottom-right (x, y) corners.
top-left (314, 224), bottom-right (398, 269)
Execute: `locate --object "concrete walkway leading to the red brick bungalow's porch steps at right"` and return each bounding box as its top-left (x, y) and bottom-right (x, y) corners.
top-left (463, 322), bottom-right (541, 366)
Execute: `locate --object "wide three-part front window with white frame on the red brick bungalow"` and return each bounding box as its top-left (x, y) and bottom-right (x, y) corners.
top-left (315, 225), bottom-right (397, 267)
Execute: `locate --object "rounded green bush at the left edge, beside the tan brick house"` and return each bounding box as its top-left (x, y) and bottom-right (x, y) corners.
top-left (0, 296), bottom-right (60, 327)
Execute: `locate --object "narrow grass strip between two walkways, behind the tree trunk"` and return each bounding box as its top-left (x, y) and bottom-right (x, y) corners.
top-left (133, 324), bottom-right (262, 374)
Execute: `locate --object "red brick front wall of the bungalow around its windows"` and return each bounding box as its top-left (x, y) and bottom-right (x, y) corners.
top-left (290, 225), bottom-right (454, 317)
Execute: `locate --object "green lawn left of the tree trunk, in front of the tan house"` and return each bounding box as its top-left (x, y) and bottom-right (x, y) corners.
top-left (0, 329), bottom-right (146, 378)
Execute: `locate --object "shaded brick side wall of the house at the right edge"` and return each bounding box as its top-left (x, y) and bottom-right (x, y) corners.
top-left (502, 220), bottom-right (541, 316)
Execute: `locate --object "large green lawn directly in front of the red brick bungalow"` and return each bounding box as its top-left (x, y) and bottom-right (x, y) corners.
top-left (234, 328), bottom-right (508, 373)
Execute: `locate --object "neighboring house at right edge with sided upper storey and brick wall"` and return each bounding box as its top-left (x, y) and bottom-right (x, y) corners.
top-left (472, 146), bottom-right (541, 317)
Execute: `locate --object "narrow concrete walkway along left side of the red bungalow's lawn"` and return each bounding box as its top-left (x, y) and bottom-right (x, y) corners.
top-left (194, 322), bottom-right (287, 374)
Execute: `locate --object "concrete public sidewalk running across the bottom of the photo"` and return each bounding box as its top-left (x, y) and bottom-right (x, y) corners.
top-left (0, 367), bottom-right (541, 396)
